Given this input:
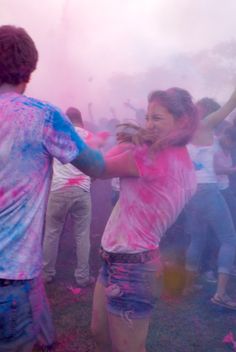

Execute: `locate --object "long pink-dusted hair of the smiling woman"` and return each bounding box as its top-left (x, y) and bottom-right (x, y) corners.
top-left (117, 87), bottom-right (198, 150)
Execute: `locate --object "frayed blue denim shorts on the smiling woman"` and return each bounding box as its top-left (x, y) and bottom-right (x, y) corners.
top-left (98, 254), bottom-right (161, 320)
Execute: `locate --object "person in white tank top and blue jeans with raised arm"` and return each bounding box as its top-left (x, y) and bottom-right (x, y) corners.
top-left (184, 91), bottom-right (236, 309)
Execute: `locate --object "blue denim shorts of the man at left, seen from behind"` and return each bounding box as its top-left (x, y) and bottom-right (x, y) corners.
top-left (0, 278), bottom-right (52, 352)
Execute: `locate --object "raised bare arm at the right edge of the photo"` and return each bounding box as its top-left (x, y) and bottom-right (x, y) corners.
top-left (202, 89), bottom-right (236, 129)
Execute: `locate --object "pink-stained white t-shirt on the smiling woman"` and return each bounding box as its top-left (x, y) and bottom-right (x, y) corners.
top-left (102, 147), bottom-right (196, 253)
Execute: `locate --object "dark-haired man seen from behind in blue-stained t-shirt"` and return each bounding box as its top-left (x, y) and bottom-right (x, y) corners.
top-left (0, 26), bottom-right (104, 352)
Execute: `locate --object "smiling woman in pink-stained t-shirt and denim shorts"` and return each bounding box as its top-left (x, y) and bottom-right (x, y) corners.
top-left (92, 88), bottom-right (197, 352)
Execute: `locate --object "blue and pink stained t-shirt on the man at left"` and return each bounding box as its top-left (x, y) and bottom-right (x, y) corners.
top-left (0, 93), bottom-right (86, 279)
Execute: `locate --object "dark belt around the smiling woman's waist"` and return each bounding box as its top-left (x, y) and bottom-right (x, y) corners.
top-left (100, 248), bottom-right (159, 264)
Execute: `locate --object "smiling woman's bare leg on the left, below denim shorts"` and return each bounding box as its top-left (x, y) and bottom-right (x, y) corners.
top-left (91, 281), bottom-right (112, 352)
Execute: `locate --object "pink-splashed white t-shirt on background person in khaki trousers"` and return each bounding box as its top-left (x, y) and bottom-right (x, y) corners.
top-left (51, 127), bottom-right (91, 192)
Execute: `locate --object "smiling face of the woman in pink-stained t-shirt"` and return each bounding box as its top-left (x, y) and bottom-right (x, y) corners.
top-left (146, 101), bottom-right (176, 137)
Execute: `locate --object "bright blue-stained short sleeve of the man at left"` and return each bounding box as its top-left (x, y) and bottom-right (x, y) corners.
top-left (43, 107), bottom-right (87, 164)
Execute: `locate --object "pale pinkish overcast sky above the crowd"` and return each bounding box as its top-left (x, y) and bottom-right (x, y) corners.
top-left (0, 0), bottom-right (236, 119)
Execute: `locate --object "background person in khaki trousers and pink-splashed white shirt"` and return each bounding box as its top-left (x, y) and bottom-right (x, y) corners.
top-left (43, 107), bottom-right (94, 287)
